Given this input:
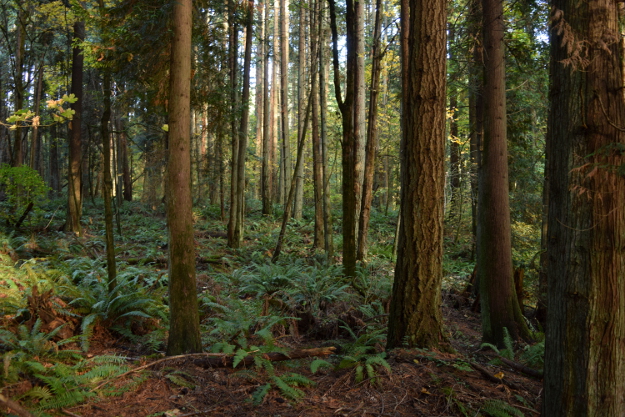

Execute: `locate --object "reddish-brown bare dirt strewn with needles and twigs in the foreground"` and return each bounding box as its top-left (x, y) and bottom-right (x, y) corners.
top-left (63, 299), bottom-right (542, 417)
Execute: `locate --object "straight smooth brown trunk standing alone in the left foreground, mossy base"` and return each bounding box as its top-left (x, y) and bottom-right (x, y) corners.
top-left (167, 0), bottom-right (202, 355)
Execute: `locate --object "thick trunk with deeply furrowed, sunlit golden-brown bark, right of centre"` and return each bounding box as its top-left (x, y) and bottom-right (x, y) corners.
top-left (387, 0), bottom-right (447, 348)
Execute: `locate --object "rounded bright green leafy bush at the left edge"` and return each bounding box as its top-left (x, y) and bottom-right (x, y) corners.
top-left (0, 164), bottom-right (50, 225)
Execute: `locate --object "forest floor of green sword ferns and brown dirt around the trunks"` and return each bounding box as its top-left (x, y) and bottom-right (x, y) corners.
top-left (0, 200), bottom-right (542, 417)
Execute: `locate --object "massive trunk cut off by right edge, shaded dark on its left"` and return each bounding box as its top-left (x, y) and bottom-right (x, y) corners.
top-left (542, 0), bottom-right (625, 417)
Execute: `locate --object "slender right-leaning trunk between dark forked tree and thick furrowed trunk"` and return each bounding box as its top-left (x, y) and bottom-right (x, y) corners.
top-left (356, 0), bottom-right (383, 261)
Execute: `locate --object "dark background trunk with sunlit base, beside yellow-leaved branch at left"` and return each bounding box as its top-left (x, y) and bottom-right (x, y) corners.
top-left (66, 22), bottom-right (85, 235)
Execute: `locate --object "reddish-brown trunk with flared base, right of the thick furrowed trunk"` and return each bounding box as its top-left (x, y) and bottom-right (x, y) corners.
top-left (477, 0), bottom-right (530, 345)
